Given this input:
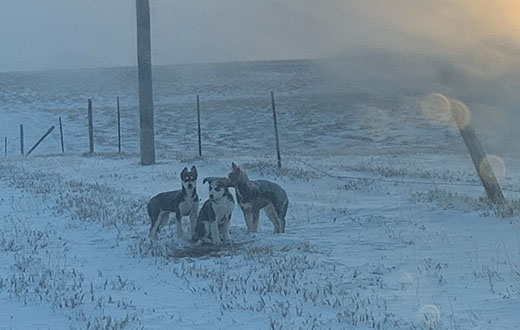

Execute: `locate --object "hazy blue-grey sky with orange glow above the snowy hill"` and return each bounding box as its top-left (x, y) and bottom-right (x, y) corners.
top-left (0, 0), bottom-right (520, 71)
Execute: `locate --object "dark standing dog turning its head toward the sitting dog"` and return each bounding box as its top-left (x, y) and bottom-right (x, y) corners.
top-left (228, 162), bottom-right (289, 233)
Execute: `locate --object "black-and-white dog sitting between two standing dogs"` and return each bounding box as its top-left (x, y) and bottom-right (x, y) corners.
top-left (192, 177), bottom-right (235, 245)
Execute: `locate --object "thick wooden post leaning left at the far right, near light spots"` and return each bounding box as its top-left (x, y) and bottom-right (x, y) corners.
top-left (450, 100), bottom-right (506, 205)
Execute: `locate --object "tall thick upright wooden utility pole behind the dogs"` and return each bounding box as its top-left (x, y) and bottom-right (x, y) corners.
top-left (135, 0), bottom-right (155, 165)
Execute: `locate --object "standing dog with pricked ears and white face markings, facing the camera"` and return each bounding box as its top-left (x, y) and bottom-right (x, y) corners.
top-left (148, 166), bottom-right (199, 239)
